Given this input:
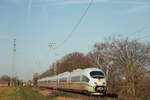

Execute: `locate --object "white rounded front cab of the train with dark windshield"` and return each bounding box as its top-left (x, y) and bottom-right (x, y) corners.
top-left (85, 68), bottom-right (107, 95)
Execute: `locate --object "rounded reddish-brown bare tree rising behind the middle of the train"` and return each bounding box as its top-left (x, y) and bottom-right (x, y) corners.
top-left (56, 52), bottom-right (92, 73)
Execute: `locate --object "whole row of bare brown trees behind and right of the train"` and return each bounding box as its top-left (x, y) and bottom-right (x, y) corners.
top-left (34, 38), bottom-right (150, 100)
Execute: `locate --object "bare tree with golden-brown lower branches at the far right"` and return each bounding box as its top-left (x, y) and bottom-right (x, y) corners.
top-left (109, 39), bottom-right (150, 96)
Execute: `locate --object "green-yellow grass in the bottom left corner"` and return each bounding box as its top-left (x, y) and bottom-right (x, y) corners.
top-left (0, 87), bottom-right (55, 100)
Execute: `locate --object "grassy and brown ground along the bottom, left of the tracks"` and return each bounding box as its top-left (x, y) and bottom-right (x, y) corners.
top-left (0, 87), bottom-right (118, 100)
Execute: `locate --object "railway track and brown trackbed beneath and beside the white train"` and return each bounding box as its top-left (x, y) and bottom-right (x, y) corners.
top-left (40, 87), bottom-right (118, 100)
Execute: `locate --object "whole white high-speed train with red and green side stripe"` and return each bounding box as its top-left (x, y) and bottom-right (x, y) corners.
top-left (37, 68), bottom-right (107, 95)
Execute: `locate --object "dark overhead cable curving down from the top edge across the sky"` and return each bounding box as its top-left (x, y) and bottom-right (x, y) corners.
top-left (58, 0), bottom-right (94, 47)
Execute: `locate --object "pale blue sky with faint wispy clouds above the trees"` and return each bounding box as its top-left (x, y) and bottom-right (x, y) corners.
top-left (0, 0), bottom-right (150, 80)
